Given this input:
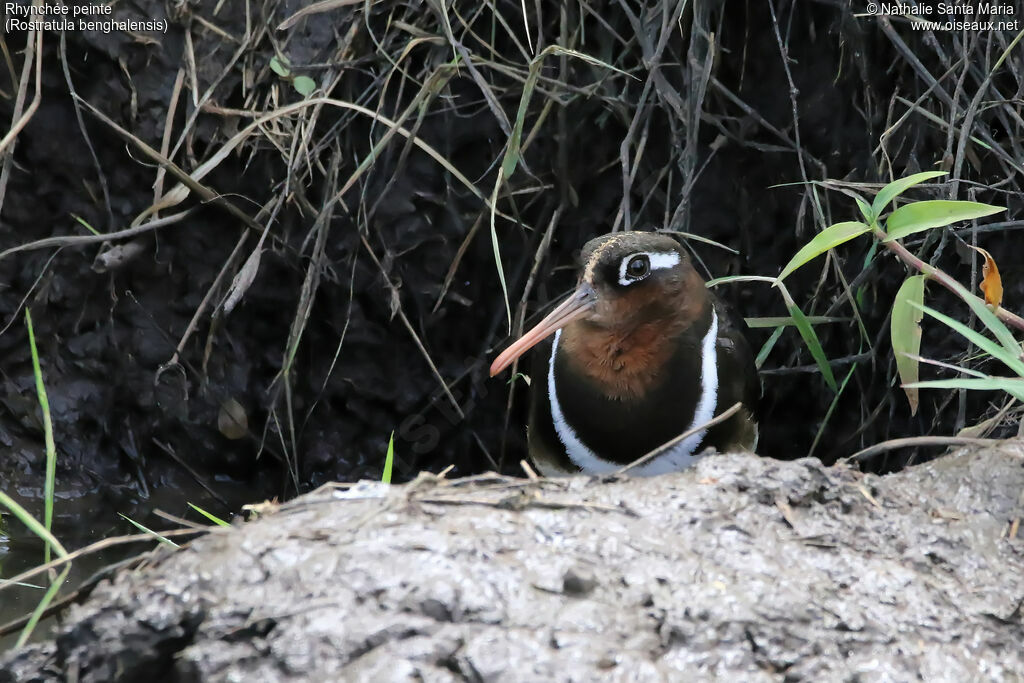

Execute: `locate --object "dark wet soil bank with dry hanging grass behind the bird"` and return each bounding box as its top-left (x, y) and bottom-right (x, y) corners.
top-left (0, 0), bottom-right (1024, 626)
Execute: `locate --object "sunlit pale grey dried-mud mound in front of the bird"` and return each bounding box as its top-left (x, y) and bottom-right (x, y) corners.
top-left (0, 440), bottom-right (1024, 682)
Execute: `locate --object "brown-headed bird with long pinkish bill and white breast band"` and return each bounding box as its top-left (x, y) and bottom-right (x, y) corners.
top-left (490, 230), bottom-right (761, 476)
